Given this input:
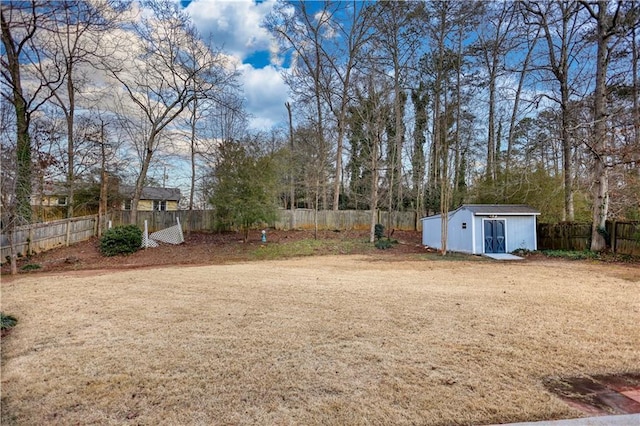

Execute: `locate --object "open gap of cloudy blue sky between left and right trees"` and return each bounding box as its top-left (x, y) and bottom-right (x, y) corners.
top-left (180, 0), bottom-right (288, 130)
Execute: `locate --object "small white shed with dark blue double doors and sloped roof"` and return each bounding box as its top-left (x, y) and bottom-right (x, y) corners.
top-left (421, 204), bottom-right (540, 254)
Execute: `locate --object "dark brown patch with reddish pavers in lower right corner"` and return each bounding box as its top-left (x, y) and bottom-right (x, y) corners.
top-left (545, 373), bottom-right (640, 415)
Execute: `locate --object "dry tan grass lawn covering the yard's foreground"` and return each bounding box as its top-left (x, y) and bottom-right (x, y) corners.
top-left (1, 256), bottom-right (640, 425)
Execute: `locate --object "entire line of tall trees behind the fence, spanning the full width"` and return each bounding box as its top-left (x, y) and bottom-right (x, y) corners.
top-left (0, 0), bottom-right (640, 270)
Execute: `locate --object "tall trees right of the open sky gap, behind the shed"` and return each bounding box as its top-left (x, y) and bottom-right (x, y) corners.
top-left (265, 0), bottom-right (640, 250)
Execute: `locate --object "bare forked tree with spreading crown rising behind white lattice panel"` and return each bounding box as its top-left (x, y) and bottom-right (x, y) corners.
top-left (105, 0), bottom-right (235, 223)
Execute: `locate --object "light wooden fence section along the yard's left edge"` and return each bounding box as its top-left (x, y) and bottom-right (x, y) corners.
top-left (0, 215), bottom-right (98, 263)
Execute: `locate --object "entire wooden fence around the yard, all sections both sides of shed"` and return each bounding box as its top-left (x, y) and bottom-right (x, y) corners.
top-left (0, 209), bottom-right (640, 263)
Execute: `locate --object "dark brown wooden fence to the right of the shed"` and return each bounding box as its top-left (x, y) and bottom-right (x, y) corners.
top-left (538, 221), bottom-right (640, 256)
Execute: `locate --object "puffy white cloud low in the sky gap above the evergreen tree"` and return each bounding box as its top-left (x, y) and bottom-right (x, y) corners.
top-left (239, 64), bottom-right (289, 130)
